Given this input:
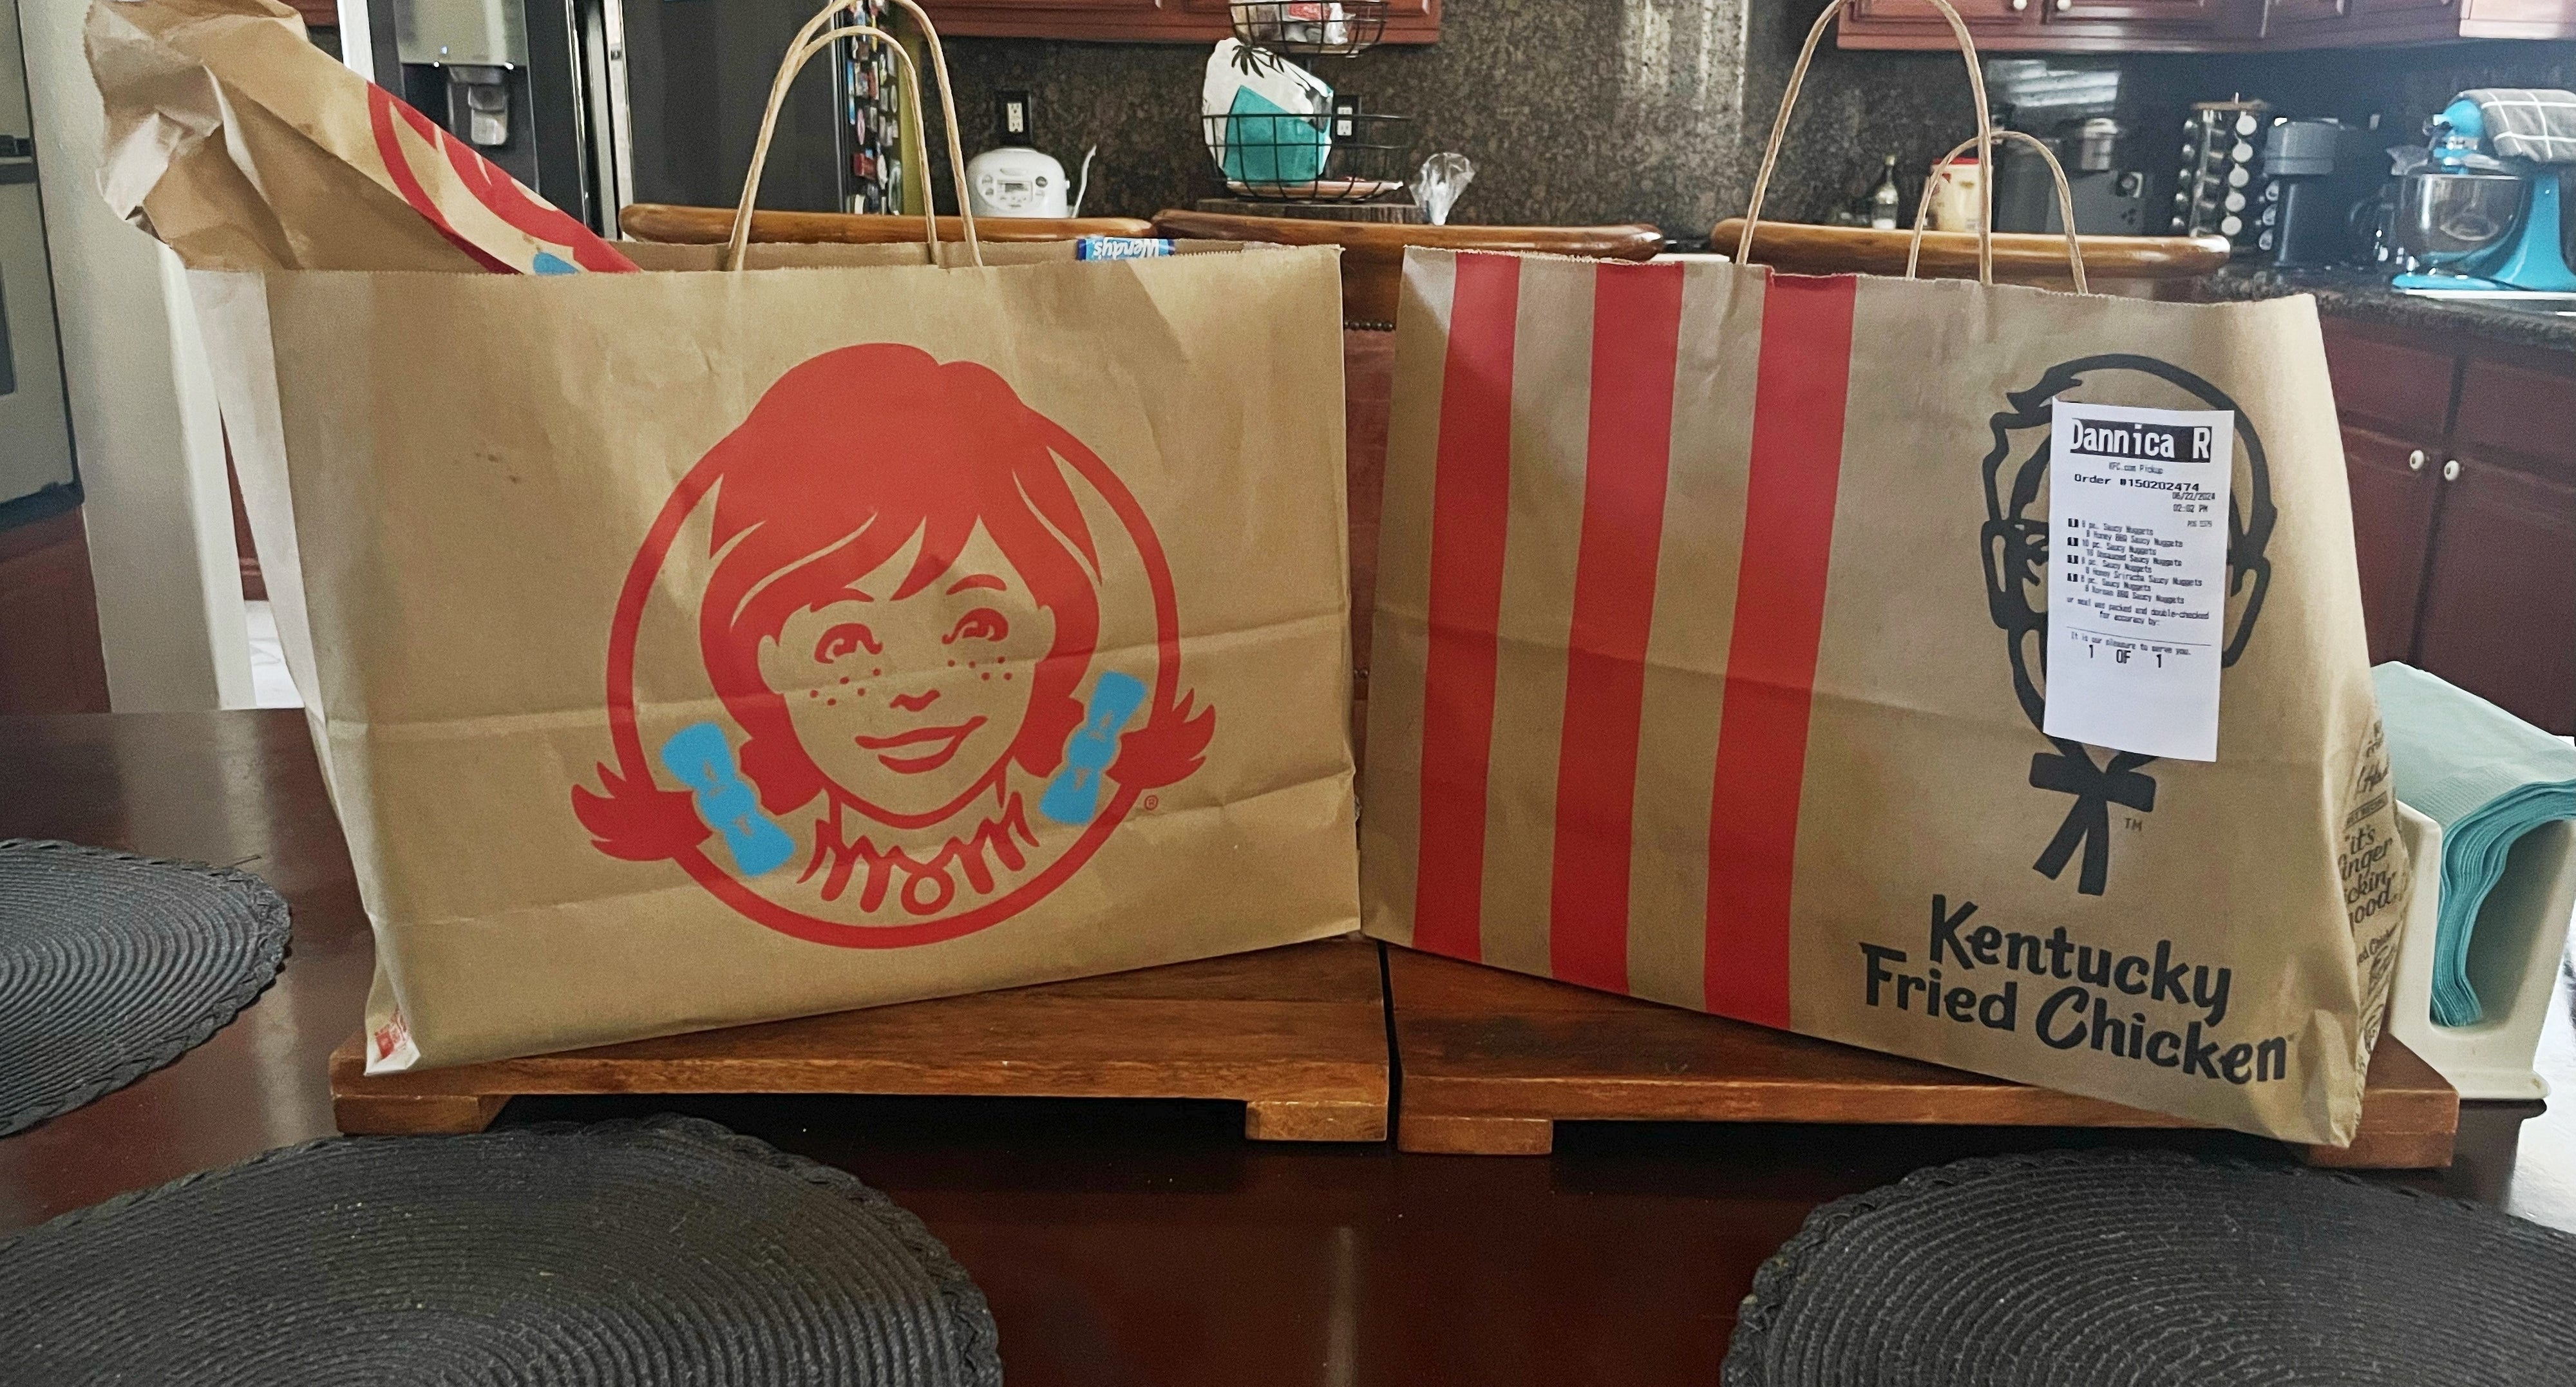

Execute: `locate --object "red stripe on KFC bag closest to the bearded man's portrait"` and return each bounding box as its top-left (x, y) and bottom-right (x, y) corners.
top-left (1705, 276), bottom-right (1860, 1026)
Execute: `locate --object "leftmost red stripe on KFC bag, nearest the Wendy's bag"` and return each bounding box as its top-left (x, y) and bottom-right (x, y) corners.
top-left (1414, 255), bottom-right (1520, 959)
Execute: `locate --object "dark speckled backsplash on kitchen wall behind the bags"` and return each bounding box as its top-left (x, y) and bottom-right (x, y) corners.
top-left (933, 0), bottom-right (2576, 237)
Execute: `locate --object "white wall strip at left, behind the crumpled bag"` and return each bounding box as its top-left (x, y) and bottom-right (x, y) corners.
top-left (18, 0), bottom-right (252, 712)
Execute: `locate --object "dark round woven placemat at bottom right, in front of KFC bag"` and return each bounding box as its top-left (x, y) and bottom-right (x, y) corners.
top-left (1721, 1153), bottom-right (2576, 1387)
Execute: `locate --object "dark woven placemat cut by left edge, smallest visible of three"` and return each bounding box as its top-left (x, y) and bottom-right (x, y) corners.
top-left (0, 838), bottom-right (289, 1137)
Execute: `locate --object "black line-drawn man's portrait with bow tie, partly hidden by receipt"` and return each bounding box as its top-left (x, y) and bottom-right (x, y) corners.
top-left (1981, 354), bottom-right (2277, 894)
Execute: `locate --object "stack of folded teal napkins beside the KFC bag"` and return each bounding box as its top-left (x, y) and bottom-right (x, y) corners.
top-left (2370, 663), bottom-right (2576, 1026)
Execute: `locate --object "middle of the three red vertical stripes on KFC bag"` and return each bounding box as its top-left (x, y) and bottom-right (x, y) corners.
top-left (1548, 265), bottom-right (1682, 992)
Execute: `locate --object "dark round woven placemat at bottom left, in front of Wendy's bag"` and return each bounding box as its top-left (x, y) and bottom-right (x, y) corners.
top-left (0, 1117), bottom-right (1002, 1387)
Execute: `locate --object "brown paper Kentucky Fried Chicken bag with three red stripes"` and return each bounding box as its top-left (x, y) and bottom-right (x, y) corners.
top-left (1363, 8), bottom-right (2409, 1145)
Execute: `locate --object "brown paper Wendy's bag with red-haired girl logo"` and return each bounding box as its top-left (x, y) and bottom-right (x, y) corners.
top-left (171, 0), bottom-right (1358, 1070)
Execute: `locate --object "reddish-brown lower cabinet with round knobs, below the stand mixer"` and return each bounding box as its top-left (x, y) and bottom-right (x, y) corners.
top-left (2326, 319), bottom-right (2576, 735)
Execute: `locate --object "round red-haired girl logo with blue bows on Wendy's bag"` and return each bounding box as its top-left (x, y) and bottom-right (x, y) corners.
top-left (572, 345), bottom-right (1216, 948)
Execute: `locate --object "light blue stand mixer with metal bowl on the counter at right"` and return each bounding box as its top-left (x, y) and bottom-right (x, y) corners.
top-left (2391, 88), bottom-right (2576, 299)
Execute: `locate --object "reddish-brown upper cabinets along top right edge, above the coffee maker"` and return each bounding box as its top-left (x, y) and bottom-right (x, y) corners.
top-left (1834, 0), bottom-right (2576, 52)
